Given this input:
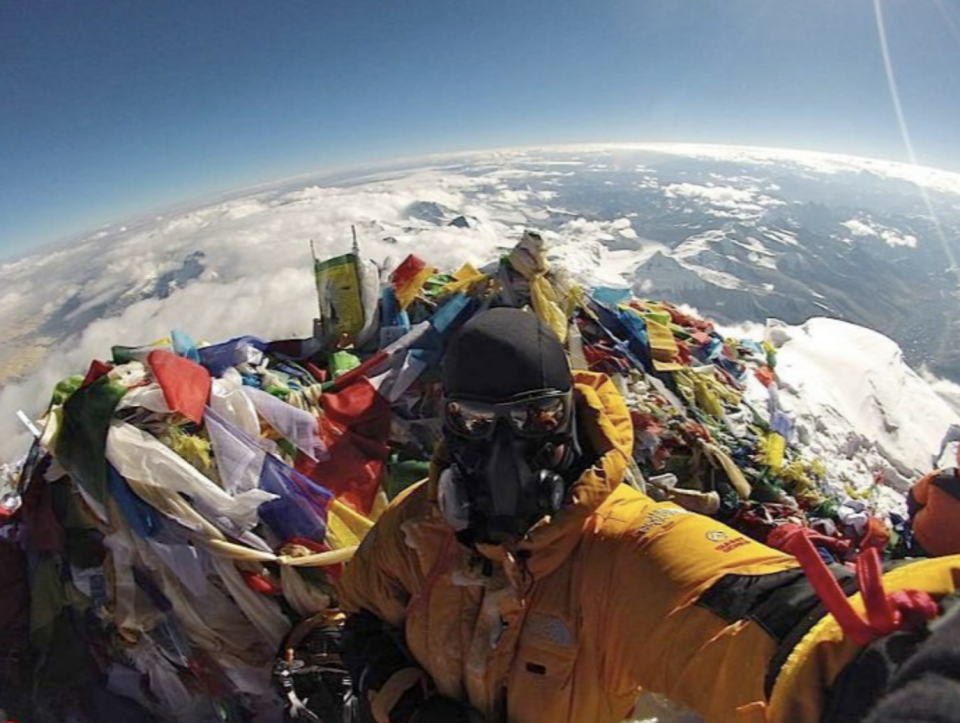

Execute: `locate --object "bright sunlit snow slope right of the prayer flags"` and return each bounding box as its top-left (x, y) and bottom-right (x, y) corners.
top-left (752, 318), bottom-right (960, 506)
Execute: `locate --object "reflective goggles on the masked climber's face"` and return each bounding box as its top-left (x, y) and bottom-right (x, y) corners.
top-left (442, 389), bottom-right (573, 440)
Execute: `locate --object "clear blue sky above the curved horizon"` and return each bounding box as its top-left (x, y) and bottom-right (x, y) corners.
top-left (0, 0), bottom-right (960, 258)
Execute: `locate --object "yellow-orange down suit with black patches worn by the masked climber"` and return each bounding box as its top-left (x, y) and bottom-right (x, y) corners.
top-left (340, 373), bottom-right (960, 723)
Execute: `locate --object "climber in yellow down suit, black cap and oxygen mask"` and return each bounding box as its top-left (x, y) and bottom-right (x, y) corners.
top-left (340, 308), bottom-right (960, 723)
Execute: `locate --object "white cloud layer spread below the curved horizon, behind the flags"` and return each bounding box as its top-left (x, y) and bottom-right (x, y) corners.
top-left (0, 145), bottom-right (960, 460)
